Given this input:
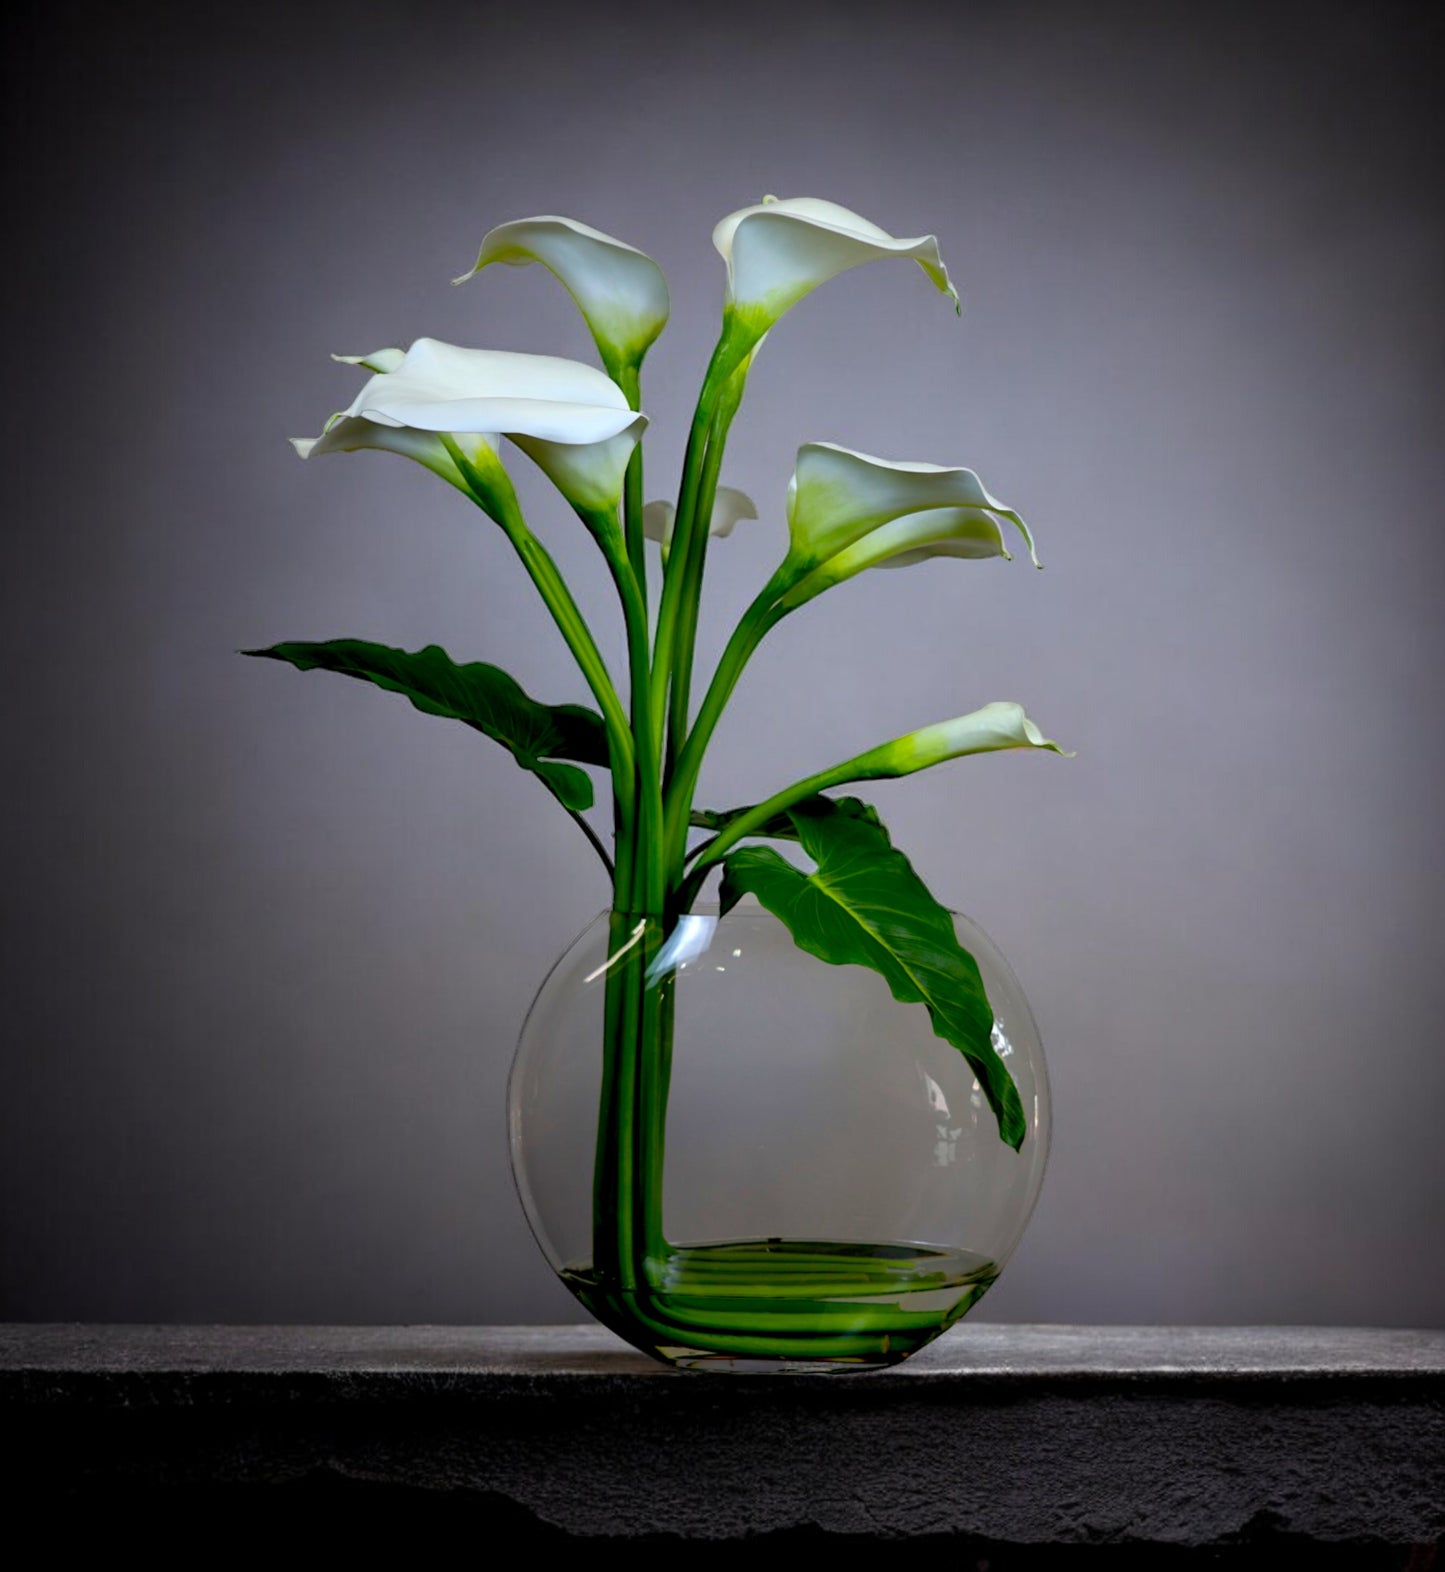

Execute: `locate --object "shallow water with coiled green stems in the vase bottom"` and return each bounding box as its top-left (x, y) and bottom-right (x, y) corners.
top-left (561, 1239), bottom-right (998, 1376)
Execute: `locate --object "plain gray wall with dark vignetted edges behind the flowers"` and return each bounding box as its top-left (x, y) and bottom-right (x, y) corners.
top-left (0, 0), bottom-right (1445, 1324)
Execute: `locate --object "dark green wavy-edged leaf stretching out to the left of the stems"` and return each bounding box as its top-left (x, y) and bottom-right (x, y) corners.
top-left (242, 638), bottom-right (609, 813)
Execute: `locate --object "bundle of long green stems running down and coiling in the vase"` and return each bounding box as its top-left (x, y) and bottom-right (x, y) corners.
top-left (584, 319), bottom-right (992, 1368)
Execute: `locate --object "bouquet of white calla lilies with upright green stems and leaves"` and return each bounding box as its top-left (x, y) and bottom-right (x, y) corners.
top-left (247, 198), bottom-right (1061, 1351)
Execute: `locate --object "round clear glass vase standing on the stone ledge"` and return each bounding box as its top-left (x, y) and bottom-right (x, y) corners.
top-left (509, 898), bottom-right (1049, 1371)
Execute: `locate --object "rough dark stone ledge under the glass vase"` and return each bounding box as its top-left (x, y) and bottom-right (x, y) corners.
top-left (0, 1324), bottom-right (1445, 1567)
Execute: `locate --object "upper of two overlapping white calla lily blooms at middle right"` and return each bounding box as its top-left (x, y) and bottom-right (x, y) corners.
top-left (785, 442), bottom-right (1038, 586)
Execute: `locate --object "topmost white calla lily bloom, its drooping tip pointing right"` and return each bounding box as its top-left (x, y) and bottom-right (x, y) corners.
top-left (712, 197), bottom-right (959, 364)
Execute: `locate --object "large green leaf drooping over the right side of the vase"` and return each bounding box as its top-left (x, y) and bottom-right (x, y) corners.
top-left (722, 795), bottom-right (1027, 1151)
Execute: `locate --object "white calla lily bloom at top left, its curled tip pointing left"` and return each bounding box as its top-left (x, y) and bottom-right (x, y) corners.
top-left (453, 214), bottom-right (670, 388)
